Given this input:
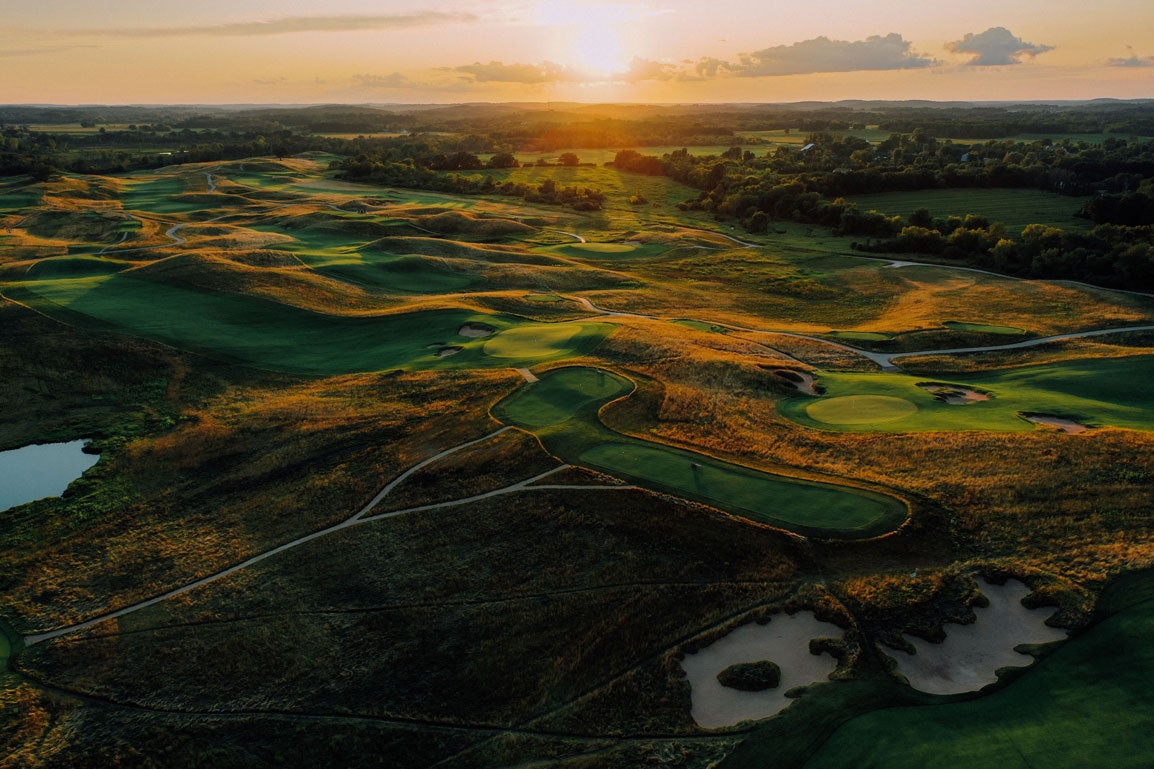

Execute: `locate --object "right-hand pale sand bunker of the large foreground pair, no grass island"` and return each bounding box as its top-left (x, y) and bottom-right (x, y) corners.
top-left (887, 580), bottom-right (1066, 694)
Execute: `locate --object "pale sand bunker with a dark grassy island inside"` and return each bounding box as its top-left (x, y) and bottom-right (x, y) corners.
top-left (681, 612), bottom-right (841, 729)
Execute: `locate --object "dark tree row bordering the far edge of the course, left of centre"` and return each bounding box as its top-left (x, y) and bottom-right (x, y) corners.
top-left (332, 155), bottom-right (605, 211)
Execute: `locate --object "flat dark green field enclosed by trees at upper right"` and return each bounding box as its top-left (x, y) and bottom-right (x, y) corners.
top-left (849, 189), bottom-right (1093, 232)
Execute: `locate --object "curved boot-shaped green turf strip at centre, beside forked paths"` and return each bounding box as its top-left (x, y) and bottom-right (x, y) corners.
top-left (493, 367), bottom-right (906, 538)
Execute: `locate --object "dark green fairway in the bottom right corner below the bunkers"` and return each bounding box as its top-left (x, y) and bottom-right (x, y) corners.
top-left (804, 573), bottom-right (1154, 769)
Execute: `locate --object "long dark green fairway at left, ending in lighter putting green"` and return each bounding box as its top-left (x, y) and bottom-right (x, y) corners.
top-left (6, 274), bottom-right (613, 375)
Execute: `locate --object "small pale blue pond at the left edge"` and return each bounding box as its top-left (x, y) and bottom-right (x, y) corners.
top-left (0, 441), bottom-right (100, 510)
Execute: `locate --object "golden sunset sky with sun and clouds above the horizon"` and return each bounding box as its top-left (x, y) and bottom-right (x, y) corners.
top-left (0, 0), bottom-right (1154, 104)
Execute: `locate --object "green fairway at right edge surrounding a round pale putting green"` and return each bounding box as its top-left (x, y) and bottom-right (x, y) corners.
top-left (778, 356), bottom-right (1154, 432)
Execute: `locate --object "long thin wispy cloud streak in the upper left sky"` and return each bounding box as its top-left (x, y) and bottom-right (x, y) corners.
top-left (55, 10), bottom-right (478, 38)
